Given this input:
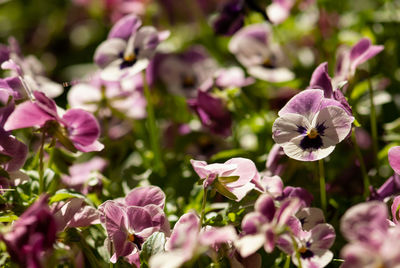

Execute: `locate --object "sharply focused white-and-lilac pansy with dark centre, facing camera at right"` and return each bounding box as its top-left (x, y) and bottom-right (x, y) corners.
top-left (272, 89), bottom-right (354, 161)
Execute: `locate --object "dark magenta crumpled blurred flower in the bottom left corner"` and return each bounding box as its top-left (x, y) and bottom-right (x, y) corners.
top-left (0, 196), bottom-right (57, 268)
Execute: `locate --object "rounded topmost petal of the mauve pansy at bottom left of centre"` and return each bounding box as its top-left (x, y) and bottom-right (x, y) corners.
top-left (125, 186), bottom-right (165, 208)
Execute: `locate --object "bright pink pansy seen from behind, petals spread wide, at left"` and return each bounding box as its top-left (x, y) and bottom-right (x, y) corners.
top-left (4, 91), bottom-right (104, 152)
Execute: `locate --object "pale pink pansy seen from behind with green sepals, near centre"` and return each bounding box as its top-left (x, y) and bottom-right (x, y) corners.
top-left (190, 157), bottom-right (264, 201)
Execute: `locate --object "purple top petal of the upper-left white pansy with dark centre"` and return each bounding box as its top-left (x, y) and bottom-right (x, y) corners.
top-left (107, 14), bottom-right (142, 41)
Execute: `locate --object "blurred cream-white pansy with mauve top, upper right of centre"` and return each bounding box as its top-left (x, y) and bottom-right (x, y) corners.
top-left (229, 24), bottom-right (294, 82)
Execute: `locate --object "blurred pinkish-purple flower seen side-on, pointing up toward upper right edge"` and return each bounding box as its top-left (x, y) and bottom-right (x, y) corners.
top-left (333, 38), bottom-right (384, 90)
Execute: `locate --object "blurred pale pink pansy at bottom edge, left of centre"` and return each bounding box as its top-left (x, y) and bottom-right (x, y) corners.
top-left (149, 212), bottom-right (237, 268)
